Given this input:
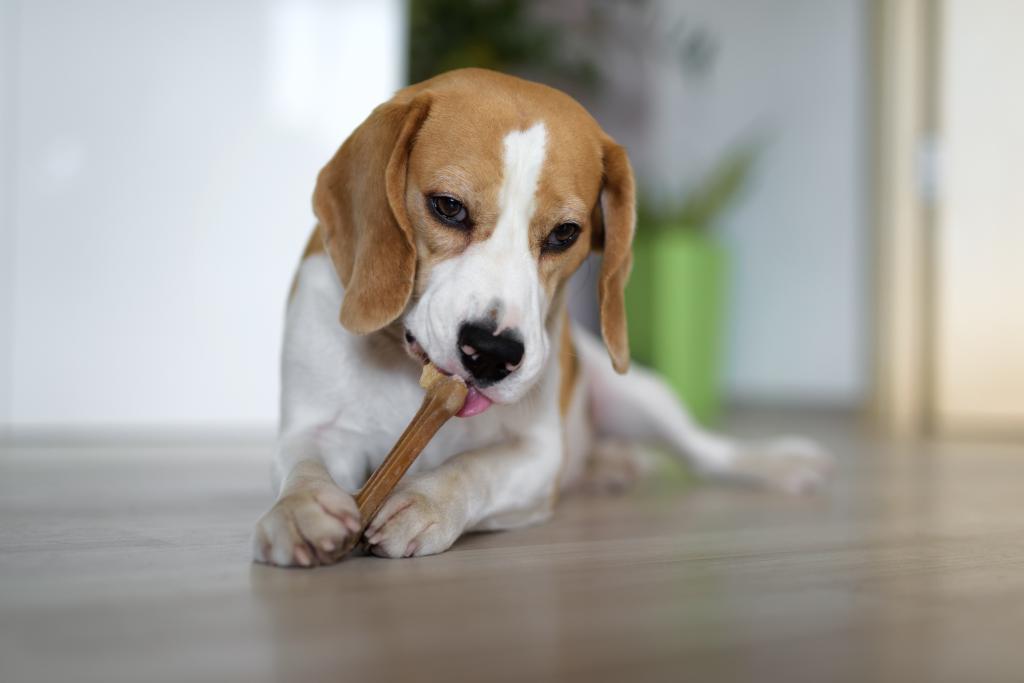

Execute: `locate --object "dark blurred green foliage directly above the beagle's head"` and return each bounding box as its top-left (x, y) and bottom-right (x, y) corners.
top-left (409, 0), bottom-right (600, 88)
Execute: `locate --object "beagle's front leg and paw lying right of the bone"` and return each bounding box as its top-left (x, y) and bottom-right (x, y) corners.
top-left (366, 427), bottom-right (562, 557)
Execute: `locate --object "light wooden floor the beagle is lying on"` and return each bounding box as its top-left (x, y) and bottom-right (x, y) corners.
top-left (0, 414), bottom-right (1024, 683)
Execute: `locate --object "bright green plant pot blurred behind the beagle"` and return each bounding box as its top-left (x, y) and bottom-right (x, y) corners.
top-left (626, 225), bottom-right (728, 424)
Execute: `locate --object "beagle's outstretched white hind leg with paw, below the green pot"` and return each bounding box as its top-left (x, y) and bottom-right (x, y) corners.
top-left (572, 328), bottom-right (831, 493)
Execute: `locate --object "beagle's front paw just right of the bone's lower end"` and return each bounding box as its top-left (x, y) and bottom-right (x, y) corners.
top-left (366, 488), bottom-right (464, 557)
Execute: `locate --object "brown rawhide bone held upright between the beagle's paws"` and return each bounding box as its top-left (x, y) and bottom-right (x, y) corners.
top-left (343, 362), bottom-right (468, 553)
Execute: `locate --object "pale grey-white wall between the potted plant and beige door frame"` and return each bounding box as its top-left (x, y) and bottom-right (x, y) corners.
top-left (644, 0), bottom-right (869, 403)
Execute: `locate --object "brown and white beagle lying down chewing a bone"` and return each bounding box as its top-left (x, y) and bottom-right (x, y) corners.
top-left (253, 69), bottom-right (827, 566)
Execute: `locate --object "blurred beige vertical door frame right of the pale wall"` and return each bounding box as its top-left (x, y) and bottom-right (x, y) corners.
top-left (870, 0), bottom-right (941, 437)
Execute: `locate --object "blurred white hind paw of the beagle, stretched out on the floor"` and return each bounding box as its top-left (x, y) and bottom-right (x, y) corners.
top-left (733, 436), bottom-right (834, 494)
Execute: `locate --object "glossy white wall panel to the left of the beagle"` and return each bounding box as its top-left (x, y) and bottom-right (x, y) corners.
top-left (0, 0), bottom-right (404, 428)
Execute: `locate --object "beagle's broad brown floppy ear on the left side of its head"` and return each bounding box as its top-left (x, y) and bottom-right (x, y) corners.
top-left (313, 95), bottom-right (430, 334)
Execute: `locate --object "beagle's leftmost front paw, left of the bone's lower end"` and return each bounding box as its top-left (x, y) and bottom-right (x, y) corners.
top-left (253, 484), bottom-right (359, 567)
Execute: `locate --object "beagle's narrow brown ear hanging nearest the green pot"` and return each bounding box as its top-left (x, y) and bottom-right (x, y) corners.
top-left (594, 138), bottom-right (637, 373)
